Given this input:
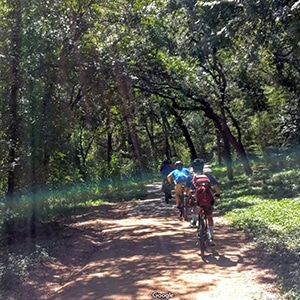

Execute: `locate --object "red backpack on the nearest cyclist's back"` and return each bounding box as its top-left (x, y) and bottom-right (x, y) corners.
top-left (192, 174), bottom-right (214, 206)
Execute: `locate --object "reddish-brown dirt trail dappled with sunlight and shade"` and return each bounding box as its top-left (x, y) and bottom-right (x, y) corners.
top-left (44, 184), bottom-right (281, 300)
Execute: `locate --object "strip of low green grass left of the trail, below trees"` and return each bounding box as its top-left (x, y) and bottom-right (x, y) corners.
top-left (0, 181), bottom-right (146, 229)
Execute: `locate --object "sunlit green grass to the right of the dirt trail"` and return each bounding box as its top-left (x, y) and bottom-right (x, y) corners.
top-left (218, 169), bottom-right (300, 300)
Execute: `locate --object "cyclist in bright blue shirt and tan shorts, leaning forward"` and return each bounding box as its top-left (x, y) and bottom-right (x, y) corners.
top-left (167, 160), bottom-right (191, 209)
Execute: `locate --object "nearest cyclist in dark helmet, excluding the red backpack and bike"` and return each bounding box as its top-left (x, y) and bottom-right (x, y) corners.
top-left (190, 158), bottom-right (220, 246)
